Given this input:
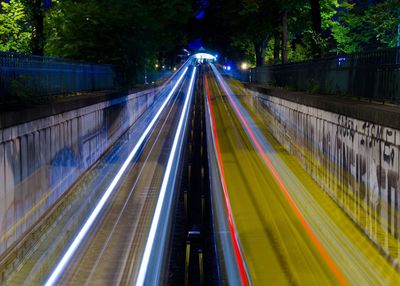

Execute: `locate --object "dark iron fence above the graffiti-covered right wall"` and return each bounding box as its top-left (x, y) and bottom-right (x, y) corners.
top-left (234, 48), bottom-right (400, 102)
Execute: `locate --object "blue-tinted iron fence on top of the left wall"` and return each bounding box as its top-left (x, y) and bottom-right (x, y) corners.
top-left (0, 52), bottom-right (117, 102)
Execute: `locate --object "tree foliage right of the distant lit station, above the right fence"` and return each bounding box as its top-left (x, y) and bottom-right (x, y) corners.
top-left (203, 0), bottom-right (400, 65)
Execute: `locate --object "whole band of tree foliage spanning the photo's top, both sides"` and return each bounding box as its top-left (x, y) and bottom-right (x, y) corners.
top-left (0, 0), bottom-right (400, 70)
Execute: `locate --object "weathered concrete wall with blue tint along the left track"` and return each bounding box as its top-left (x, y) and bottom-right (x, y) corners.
top-left (0, 89), bottom-right (159, 255)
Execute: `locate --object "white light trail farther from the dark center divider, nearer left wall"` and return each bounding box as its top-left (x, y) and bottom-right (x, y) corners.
top-left (45, 67), bottom-right (188, 286)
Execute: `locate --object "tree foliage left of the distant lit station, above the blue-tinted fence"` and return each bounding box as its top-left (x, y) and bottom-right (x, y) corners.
top-left (0, 0), bottom-right (192, 82)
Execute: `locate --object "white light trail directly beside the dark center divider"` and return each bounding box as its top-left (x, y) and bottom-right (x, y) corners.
top-left (136, 67), bottom-right (196, 286)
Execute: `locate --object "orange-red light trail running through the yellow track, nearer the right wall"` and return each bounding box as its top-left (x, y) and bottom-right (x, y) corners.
top-left (211, 64), bottom-right (348, 285)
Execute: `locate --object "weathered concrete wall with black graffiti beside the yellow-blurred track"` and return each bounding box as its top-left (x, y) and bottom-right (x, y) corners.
top-left (253, 92), bottom-right (400, 258)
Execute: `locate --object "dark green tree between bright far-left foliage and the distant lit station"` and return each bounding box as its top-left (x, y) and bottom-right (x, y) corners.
top-left (45, 0), bottom-right (192, 82)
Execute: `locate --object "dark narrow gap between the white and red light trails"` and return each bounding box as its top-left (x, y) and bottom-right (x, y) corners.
top-left (168, 63), bottom-right (221, 285)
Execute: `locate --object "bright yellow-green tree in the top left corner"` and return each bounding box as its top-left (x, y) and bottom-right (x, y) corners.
top-left (0, 0), bottom-right (31, 53)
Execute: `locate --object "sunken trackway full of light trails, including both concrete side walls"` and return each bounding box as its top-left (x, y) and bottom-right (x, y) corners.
top-left (0, 57), bottom-right (400, 285)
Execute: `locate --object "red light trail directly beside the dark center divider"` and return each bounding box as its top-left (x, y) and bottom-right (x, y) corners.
top-left (205, 76), bottom-right (248, 285)
